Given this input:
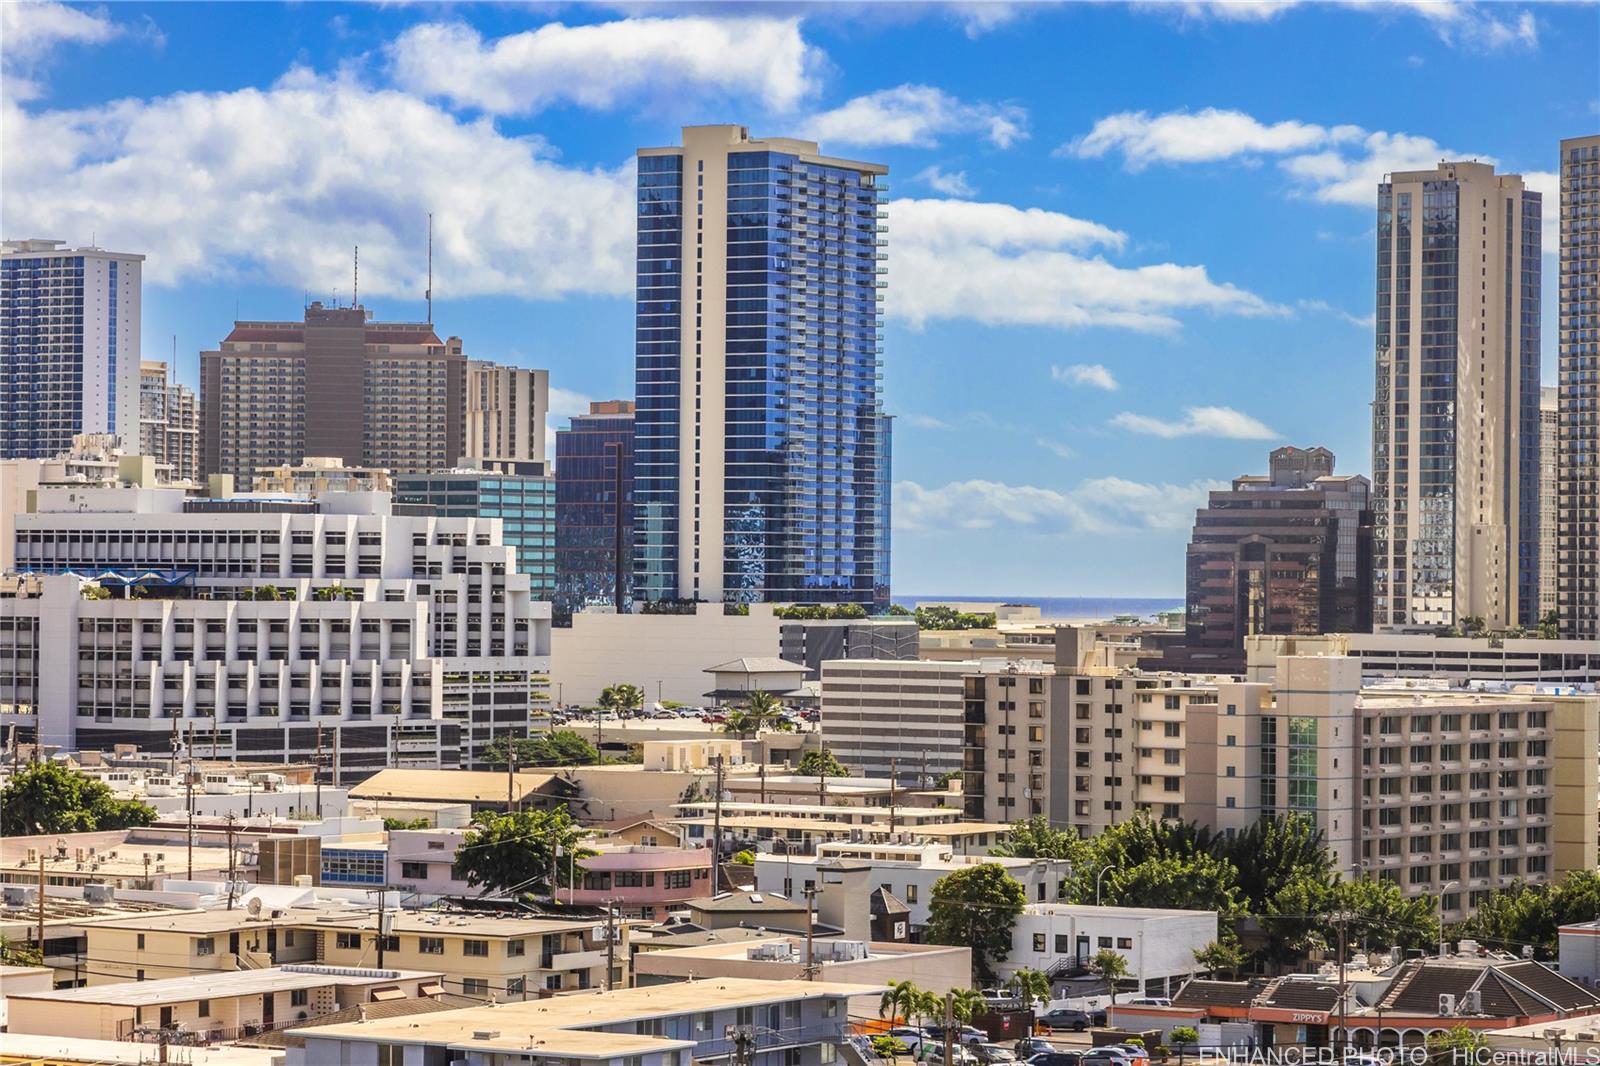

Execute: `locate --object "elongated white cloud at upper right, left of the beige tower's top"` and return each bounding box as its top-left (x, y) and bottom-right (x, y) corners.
top-left (1058, 107), bottom-right (1360, 170)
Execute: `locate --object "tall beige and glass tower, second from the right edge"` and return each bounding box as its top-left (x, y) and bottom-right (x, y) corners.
top-left (1373, 163), bottom-right (1541, 629)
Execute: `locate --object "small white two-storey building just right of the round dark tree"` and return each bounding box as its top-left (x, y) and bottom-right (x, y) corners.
top-left (997, 903), bottom-right (1216, 996)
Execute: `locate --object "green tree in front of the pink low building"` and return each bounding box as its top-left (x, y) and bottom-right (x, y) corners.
top-left (456, 808), bottom-right (594, 896)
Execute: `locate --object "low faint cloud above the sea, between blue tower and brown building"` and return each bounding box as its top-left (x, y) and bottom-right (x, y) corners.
top-left (894, 477), bottom-right (1224, 535)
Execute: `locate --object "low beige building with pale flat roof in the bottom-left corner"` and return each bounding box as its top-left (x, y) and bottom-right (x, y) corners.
top-left (6, 965), bottom-right (443, 1044)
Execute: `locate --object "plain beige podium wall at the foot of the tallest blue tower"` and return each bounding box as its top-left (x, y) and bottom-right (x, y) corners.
top-left (550, 601), bottom-right (778, 706)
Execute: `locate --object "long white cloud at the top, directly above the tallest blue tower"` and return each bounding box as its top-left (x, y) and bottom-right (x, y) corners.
top-left (389, 16), bottom-right (821, 114)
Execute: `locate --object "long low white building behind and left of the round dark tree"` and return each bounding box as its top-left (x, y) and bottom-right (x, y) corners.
top-left (755, 829), bottom-right (1093, 928)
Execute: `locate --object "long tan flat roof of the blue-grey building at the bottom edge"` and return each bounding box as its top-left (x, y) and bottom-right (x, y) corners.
top-left (304, 978), bottom-right (883, 1053)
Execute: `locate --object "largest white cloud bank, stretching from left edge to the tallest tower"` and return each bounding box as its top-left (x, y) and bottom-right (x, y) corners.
top-left (0, 70), bottom-right (634, 301)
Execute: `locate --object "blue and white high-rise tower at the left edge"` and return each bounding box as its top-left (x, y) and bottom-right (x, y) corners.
top-left (0, 240), bottom-right (144, 459)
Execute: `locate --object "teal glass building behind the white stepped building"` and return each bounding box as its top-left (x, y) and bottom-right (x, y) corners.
top-left (395, 469), bottom-right (555, 600)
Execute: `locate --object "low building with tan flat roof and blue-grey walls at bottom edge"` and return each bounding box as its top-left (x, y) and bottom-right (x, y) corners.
top-left (288, 978), bottom-right (882, 1066)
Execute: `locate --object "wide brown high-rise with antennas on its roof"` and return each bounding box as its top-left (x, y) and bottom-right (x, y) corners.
top-left (200, 301), bottom-right (467, 485)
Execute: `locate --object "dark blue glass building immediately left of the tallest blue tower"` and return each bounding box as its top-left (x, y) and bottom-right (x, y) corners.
top-left (555, 400), bottom-right (634, 615)
